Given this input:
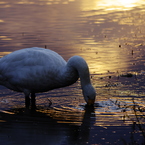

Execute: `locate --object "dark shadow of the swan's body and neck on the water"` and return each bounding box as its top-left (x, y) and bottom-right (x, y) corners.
top-left (0, 107), bottom-right (95, 145)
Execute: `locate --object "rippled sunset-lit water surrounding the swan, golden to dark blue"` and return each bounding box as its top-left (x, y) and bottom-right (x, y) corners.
top-left (0, 0), bottom-right (145, 145)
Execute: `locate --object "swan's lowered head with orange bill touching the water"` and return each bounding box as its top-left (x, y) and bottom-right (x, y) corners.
top-left (82, 84), bottom-right (96, 105)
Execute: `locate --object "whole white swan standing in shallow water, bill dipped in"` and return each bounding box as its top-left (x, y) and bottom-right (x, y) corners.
top-left (0, 47), bottom-right (96, 107)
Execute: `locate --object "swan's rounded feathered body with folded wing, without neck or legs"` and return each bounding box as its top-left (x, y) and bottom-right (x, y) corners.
top-left (0, 48), bottom-right (66, 91)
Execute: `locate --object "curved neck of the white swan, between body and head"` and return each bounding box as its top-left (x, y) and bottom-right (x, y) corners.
top-left (62, 56), bottom-right (90, 88)
